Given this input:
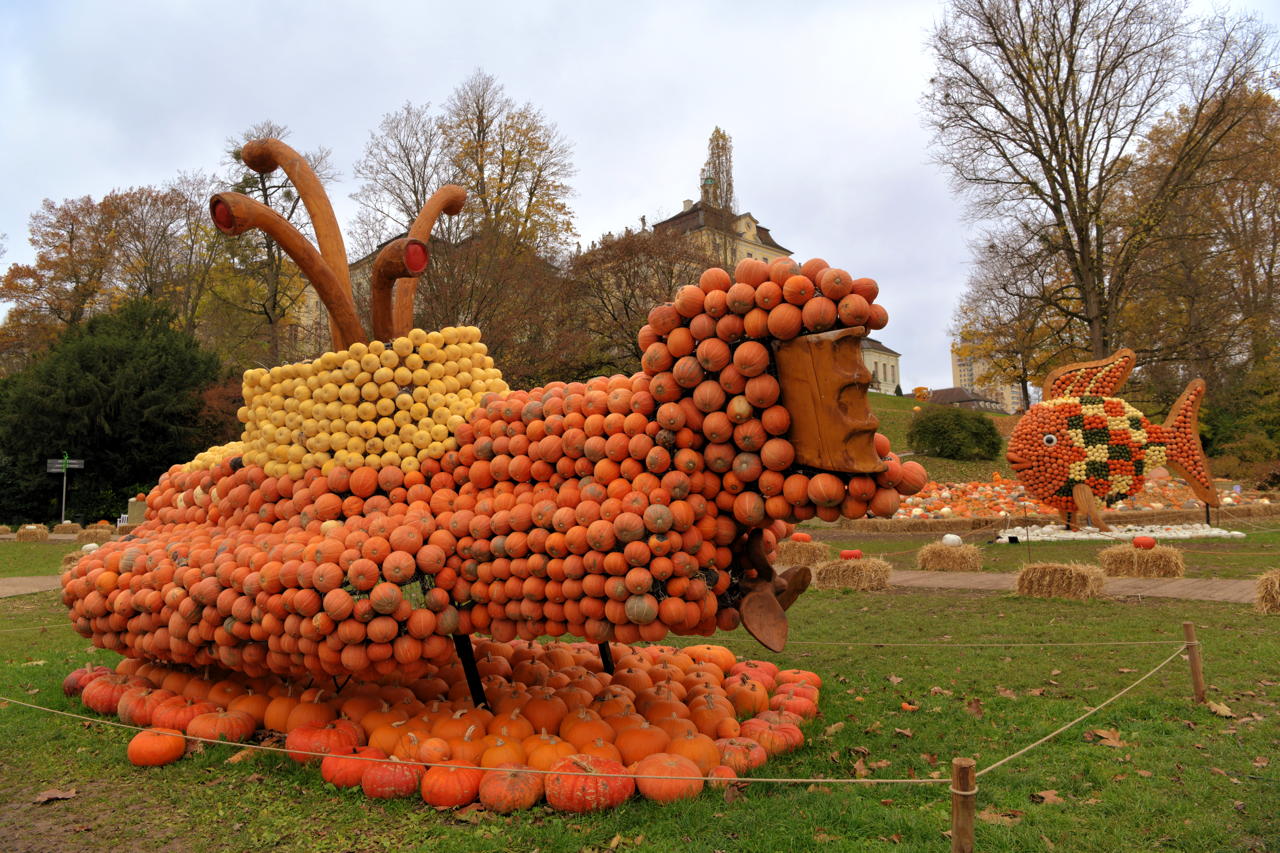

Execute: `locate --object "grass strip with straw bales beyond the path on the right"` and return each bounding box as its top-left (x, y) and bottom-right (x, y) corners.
top-left (822, 530), bottom-right (1280, 578)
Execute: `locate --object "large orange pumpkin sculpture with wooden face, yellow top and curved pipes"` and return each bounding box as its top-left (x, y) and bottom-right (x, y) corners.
top-left (61, 134), bottom-right (927, 701)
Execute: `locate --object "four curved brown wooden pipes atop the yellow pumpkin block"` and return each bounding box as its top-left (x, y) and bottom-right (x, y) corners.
top-left (209, 140), bottom-right (467, 350)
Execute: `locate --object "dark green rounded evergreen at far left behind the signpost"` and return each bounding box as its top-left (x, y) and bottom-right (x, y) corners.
top-left (0, 300), bottom-right (218, 521)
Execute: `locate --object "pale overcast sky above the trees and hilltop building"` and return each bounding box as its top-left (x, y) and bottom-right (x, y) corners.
top-left (0, 0), bottom-right (1280, 389)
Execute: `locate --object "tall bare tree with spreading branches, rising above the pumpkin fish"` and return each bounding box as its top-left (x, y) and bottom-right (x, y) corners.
top-left (924, 0), bottom-right (1272, 357)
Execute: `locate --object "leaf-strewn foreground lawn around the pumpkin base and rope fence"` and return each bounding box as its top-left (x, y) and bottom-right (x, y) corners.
top-left (0, 578), bottom-right (1280, 853)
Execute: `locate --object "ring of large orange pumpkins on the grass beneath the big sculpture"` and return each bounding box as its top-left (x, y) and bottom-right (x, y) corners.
top-left (63, 640), bottom-right (822, 813)
